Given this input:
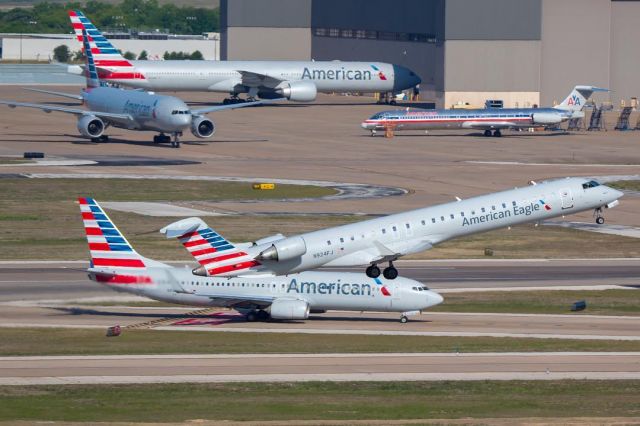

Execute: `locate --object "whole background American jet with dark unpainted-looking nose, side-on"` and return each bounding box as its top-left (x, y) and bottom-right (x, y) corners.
top-left (69, 10), bottom-right (421, 103)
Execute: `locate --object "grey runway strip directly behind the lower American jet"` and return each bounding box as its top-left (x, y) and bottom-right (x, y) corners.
top-left (0, 259), bottom-right (640, 303)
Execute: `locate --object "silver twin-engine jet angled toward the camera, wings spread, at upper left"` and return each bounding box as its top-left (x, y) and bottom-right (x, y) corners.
top-left (0, 30), bottom-right (278, 148)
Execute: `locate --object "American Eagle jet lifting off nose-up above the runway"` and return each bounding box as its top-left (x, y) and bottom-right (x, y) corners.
top-left (161, 178), bottom-right (623, 280)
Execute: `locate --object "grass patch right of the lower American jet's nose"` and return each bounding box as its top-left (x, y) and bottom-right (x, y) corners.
top-left (430, 290), bottom-right (640, 315)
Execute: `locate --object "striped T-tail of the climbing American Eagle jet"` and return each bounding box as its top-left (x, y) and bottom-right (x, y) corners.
top-left (160, 217), bottom-right (260, 276)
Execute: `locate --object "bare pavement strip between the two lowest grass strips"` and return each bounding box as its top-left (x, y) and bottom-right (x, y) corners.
top-left (0, 352), bottom-right (640, 385)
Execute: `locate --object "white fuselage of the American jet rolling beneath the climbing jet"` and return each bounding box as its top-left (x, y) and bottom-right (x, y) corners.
top-left (89, 264), bottom-right (443, 312)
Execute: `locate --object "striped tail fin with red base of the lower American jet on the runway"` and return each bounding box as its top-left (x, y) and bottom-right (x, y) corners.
top-left (78, 197), bottom-right (166, 284)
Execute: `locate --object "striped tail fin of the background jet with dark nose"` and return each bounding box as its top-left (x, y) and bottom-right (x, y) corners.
top-left (69, 10), bottom-right (133, 68)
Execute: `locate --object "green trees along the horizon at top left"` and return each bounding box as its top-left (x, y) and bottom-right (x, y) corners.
top-left (0, 0), bottom-right (220, 34)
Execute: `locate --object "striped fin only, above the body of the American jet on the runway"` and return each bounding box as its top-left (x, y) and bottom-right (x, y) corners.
top-left (78, 197), bottom-right (148, 272)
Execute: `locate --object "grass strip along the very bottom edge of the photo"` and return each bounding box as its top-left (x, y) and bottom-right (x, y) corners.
top-left (0, 380), bottom-right (640, 423)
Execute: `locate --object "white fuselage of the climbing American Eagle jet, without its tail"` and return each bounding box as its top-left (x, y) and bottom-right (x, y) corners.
top-left (256, 178), bottom-right (623, 274)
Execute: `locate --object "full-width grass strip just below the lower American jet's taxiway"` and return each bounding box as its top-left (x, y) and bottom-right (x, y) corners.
top-left (0, 327), bottom-right (640, 356)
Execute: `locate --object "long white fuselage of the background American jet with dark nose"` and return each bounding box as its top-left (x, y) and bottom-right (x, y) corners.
top-left (94, 61), bottom-right (420, 94)
